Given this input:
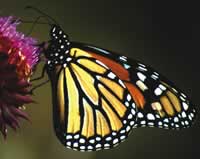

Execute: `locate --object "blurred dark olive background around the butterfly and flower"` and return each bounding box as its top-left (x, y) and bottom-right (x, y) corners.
top-left (0, 0), bottom-right (200, 159)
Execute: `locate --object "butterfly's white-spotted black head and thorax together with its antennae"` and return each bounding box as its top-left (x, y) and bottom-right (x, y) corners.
top-left (26, 6), bottom-right (70, 67)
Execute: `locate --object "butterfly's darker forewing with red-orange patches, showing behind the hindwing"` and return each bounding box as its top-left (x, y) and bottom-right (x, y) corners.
top-left (71, 42), bottom-right (196, 129)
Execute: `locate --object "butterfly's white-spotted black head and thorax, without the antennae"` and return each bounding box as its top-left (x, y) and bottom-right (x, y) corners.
top-left (44, 25), bottom-right (71, 68)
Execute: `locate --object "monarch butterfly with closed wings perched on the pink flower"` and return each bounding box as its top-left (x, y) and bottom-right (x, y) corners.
top-left (28, 6), bottom-right (196, 151)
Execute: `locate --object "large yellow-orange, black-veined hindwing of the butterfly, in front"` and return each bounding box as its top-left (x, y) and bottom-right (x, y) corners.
top-left (49, 45), bottom-right (137, 151)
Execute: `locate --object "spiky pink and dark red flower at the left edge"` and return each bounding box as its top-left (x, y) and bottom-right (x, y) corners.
top-left (0, 17), bottom-right (39, 138)
